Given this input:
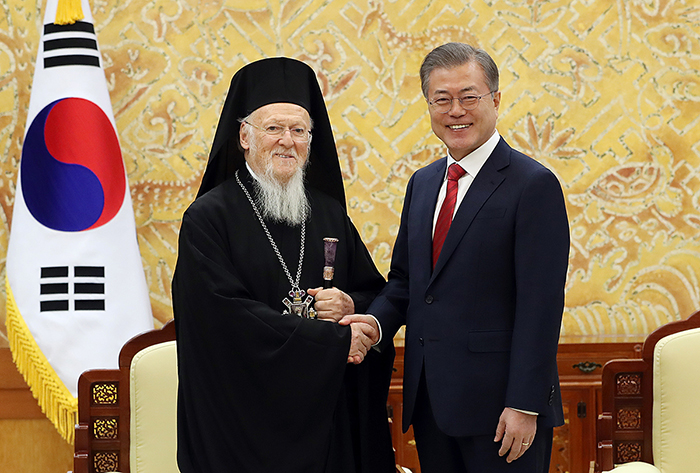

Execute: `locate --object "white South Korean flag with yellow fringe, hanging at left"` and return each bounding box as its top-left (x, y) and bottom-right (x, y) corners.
top-left (6, 0), bottom-right (153, 442)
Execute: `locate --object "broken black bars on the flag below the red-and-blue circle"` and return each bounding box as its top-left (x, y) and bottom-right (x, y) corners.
top-left (39, 266), bottom-right (105, 312)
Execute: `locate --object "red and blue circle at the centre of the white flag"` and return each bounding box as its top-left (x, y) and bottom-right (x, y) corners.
top-left (21, 97), bottom-right (126, 232)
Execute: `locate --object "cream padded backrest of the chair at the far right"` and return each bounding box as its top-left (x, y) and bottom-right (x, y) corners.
top-left (652, 328), bottom-right (700, 473)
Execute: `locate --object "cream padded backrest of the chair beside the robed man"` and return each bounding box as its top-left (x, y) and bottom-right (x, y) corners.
top-left (129, 341), bottom-right (179, 473)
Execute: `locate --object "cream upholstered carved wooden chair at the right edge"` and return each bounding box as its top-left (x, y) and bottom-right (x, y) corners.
top-left (598, 312), bottom-right (700, 473)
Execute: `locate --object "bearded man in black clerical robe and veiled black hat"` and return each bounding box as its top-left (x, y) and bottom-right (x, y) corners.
top-left (173, 58), bottom-right (395, 473)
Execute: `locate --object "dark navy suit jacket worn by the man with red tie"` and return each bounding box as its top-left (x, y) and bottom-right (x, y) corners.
top-left (367, 138), bottom-right (569, 436)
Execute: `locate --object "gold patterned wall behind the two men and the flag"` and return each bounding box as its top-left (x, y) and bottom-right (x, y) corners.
top-left (0, 0), bottom-right (700, 344)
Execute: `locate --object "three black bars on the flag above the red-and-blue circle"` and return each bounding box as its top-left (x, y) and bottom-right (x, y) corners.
top-left (44, 21), bottom-right (100, 69)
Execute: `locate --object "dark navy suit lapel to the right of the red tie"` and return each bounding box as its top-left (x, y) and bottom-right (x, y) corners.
top-left (431, 138), bottom-right (510, 274)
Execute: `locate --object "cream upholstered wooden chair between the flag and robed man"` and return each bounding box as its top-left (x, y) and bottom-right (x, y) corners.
top-left (74, 322), bottom-right (178, 473)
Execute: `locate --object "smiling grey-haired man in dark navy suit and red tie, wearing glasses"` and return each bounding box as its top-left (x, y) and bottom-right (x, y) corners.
top-left (342, 43), bottom-right (569, 473)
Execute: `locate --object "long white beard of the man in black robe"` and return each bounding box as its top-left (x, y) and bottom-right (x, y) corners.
top-left (253, 159), bottom-right (310, 226)
